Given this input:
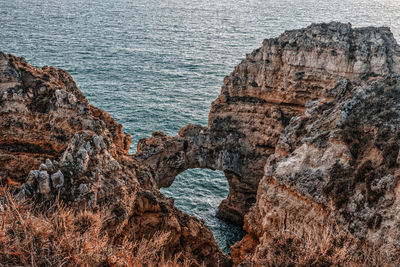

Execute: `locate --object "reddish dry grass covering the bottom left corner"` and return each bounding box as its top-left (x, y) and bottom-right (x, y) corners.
top-left (0, 188), bottom-right (192, 266)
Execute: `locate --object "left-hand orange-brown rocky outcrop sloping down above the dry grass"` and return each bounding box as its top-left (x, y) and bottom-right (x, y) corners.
top-left (0, 53), bottom-right (230, 266)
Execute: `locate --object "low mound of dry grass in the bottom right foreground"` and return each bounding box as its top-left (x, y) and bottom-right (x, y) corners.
top-left (258, 226), bottom-right (390, 266)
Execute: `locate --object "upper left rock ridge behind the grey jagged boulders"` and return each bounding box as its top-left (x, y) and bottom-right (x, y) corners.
top-left (0, 53), bottom-right (130, 181)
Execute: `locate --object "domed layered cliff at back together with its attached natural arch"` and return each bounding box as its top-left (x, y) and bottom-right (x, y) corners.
top-left (138, 22), bottom-right (400, 224)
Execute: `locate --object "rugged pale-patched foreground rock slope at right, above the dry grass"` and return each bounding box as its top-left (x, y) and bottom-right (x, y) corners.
top-left (236, 75), bottom-right (400, 263)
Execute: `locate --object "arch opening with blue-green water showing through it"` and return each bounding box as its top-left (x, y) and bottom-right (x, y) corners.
top-left (160, 169), bottom-right (245, 253)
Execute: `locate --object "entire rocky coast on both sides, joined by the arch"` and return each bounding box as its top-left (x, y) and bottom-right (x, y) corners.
top-left (0, 22), bottom-right (400, 266)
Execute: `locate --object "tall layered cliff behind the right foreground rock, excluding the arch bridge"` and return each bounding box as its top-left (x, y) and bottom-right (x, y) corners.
top-left (208, 23), bottom-right (400, 225)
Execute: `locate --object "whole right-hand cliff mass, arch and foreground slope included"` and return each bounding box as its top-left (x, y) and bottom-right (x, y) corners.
top-left (136, 22), bottom-right (400, 265)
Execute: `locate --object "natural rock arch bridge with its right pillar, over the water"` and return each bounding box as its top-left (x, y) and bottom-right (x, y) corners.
top-left (133, 124), bottom-right (262, 225)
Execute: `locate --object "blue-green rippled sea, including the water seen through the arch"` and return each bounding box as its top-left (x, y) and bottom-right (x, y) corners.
top-left (0, 0), bottom-right (400, 252)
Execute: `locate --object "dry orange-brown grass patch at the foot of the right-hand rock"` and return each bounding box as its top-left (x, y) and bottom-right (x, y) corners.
top-left (250, 211), bottom-right (394, 267)
